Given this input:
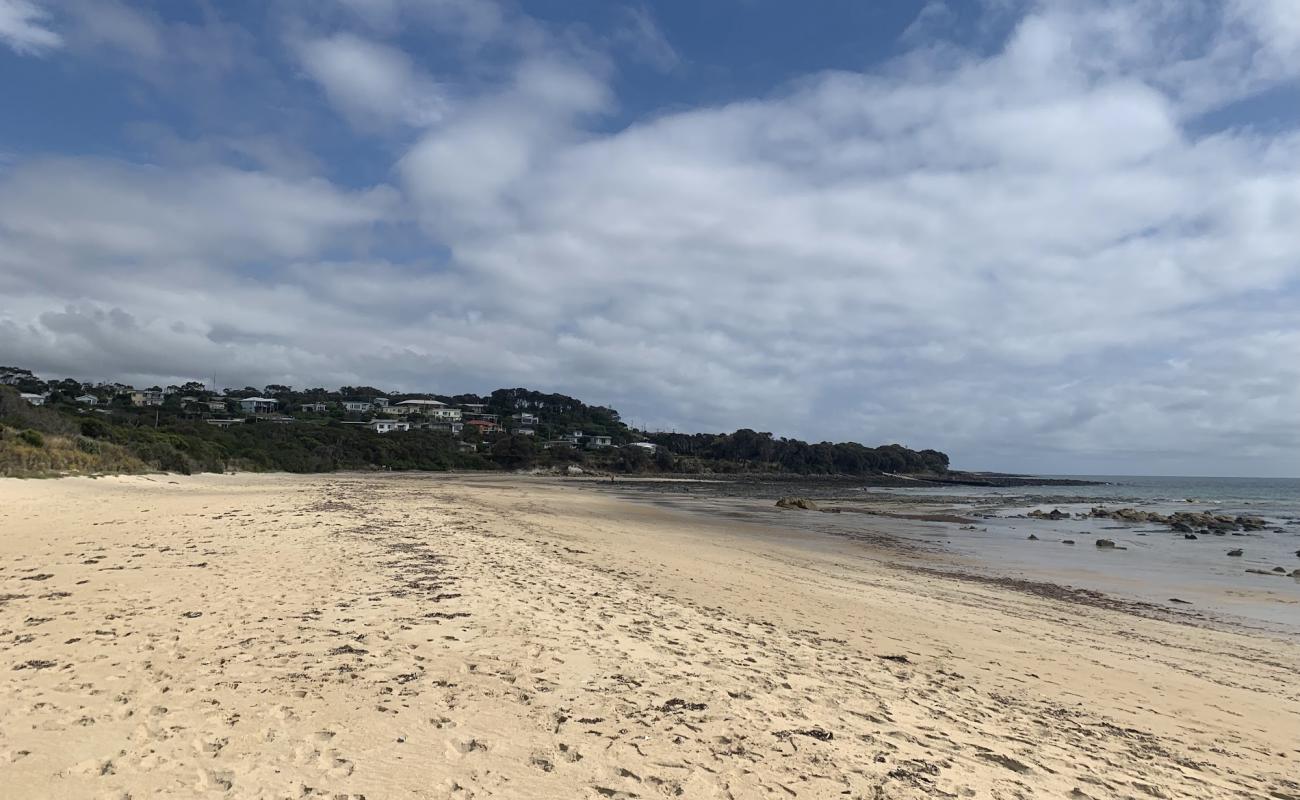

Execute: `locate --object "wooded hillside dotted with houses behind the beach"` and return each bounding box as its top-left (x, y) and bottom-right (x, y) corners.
top-left (0, 367), bottom-right (948, 475)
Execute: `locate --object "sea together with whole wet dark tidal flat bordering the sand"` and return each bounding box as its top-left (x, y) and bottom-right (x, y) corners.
top-left (601, 475), bottom-right (1300, 637)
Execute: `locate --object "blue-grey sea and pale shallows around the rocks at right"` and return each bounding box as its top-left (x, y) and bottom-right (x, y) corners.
top-left (866, 476), bottom-right (1300, 633)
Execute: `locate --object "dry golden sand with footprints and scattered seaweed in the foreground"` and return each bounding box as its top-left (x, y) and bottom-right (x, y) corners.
top-left (0, 475), bottom-right (1300, 800)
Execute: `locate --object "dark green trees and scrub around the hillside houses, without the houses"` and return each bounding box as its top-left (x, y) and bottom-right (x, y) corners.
top-left (0, 368), bottom-right (949, 476)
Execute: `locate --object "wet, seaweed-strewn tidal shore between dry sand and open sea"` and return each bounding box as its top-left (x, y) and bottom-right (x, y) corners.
top-left (585, 481), bottom-right (1300, 636)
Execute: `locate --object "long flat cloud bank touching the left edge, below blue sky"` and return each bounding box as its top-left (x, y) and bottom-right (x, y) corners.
top-left (0, 159), bottom-right (395, 268)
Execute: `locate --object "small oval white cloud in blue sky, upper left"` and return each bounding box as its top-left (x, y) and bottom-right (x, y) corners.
top-left (295, 34), bottom-right (447, 129)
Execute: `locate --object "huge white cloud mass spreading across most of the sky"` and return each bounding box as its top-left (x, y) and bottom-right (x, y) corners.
top-left (0, 0), bottom-right (1300, 473)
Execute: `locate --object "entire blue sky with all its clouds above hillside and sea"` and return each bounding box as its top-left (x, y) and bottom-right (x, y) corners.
top-left (0, 0), bottom-right (1300, 476)
